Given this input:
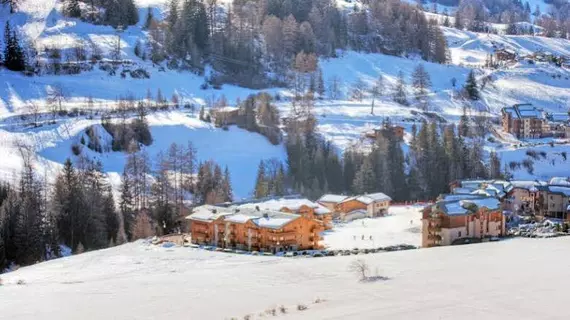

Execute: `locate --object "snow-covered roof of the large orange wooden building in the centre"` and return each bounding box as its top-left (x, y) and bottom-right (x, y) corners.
top-left (186, 205), bottom-right (301, 229)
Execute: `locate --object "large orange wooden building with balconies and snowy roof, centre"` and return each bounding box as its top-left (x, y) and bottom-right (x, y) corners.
top-left (186, 205), bottom-right (324, 253)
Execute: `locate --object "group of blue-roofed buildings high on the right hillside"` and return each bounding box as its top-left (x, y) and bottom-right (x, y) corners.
top-left (501, 104), bottom-right (570, 139)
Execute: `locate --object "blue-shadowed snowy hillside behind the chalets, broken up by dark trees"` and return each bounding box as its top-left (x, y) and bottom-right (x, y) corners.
top-left (0, 0), bottom-right (570, 190)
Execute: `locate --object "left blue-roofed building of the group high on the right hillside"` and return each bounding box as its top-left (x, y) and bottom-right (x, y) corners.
top-left (501, 104), bottom-right (543, 139)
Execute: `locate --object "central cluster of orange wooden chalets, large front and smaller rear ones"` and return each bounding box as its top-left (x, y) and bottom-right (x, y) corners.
top-left (187, 193), bottom-right (391, 253)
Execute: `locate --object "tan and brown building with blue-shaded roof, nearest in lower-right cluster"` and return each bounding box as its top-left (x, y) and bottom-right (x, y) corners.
top-left (422, 195), bottom-right (506, 248)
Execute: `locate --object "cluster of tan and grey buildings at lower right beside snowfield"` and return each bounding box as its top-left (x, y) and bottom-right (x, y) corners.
top-left (422, 177), bottom-right (570, 247)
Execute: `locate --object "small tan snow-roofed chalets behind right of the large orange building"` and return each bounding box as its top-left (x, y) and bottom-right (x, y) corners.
top-left (317, 192), bottom-right (392, 222)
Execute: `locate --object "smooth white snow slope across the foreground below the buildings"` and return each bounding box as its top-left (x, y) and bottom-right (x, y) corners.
top-left (0, 238), bottom-right (570, 320)
